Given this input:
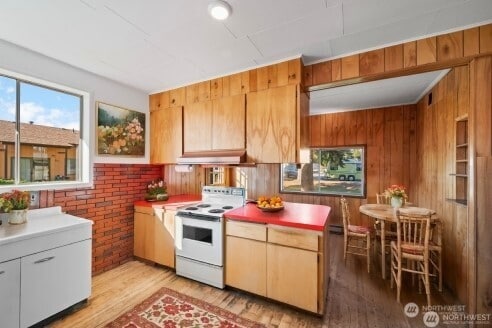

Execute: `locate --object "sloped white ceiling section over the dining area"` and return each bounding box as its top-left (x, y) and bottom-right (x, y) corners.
top-left (309, 69), bottom-right (449, 115)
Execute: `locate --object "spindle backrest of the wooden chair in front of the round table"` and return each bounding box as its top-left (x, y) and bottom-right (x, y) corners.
top-left (396, 210), bottom-right (432, 256)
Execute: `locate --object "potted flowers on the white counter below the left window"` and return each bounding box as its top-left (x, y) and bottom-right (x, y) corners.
top-left (0, 190), bottom-right (31, 224)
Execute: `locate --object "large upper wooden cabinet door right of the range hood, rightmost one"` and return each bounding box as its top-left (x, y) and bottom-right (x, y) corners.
top-left (246, 85), bottom-right (298, 163)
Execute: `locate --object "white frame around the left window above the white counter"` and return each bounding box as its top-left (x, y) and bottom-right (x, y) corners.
top-left (0, 68), bottom-right (93, 193)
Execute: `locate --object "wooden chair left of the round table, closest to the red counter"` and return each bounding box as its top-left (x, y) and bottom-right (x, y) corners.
top-left (340, 197), bottom-right (372, 273)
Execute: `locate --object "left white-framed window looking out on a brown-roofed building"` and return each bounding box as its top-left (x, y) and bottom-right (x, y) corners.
top-left (0, 69), bottom-right (90, 190)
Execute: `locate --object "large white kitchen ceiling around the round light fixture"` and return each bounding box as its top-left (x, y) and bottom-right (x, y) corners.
top-left (0, 0), bottom-right (492, 93)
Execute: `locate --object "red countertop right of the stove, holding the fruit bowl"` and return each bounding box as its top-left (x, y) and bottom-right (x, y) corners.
top-left (225, 202), bottom-right (331, 231)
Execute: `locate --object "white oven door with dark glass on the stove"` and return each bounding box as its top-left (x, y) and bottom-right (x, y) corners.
top-left (175, 215), bottom-right (223, 266)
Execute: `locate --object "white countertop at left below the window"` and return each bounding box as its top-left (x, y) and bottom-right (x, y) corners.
top-left (0, 206), bottom-right (93, 246)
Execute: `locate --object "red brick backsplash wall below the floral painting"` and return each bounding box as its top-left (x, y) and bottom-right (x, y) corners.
top-left (39, 164), bottom-right (163, 275)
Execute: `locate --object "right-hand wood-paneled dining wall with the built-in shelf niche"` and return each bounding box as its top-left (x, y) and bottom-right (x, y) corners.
top-left (411, 65), bottom-right (472, 304)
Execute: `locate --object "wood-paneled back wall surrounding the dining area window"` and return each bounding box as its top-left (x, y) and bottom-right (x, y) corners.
top-left (243, 105), bottom-right (416, 228)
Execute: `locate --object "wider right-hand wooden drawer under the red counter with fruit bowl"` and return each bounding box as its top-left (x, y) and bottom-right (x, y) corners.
top-left (268, 226), bottom-right (319, 252)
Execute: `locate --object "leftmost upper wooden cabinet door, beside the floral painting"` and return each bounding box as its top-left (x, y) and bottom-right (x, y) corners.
top-left (150, 107), bottom-right (183, 164)
